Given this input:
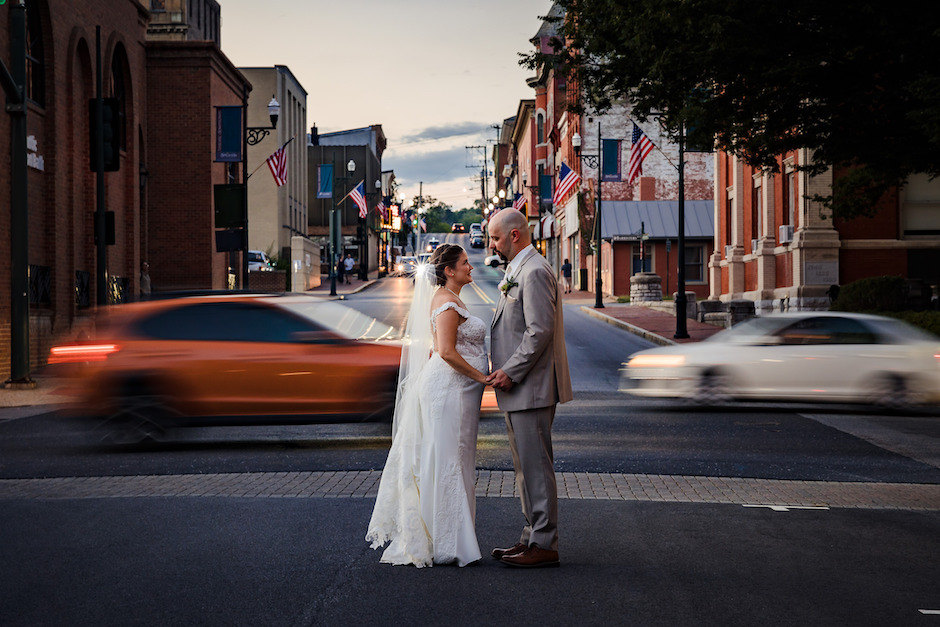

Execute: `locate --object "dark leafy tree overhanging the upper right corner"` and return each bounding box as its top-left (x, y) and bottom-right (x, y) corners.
top-left (536, 0), bottom-right (940, 218)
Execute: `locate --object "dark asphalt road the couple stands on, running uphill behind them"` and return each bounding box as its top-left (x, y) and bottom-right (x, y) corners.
top-left (0, 236), bottom-right (940, 625)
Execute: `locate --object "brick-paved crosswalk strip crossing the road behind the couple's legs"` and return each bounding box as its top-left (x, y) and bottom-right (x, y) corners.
top-left (0, 470), bottom-right (940, 511)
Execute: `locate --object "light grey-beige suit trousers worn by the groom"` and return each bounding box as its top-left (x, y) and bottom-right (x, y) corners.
top-left (506, 405), bottom-right (558, 551)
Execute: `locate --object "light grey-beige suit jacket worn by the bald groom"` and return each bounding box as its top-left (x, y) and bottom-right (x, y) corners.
top-left (490, 252), bottom-right (572, 412)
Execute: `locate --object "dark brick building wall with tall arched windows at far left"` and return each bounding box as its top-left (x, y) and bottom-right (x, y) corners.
top-left (0, 0), bottom-right (146, 379)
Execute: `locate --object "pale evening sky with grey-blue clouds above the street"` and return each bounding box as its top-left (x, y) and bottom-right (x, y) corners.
top-left (219, 0), bottom-right (552, 209)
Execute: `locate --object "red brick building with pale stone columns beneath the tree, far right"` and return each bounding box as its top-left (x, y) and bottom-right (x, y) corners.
top-left (709, 150), bottom-right (940, 312)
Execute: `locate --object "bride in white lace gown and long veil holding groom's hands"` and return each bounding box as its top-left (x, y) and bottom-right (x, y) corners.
top-left (366, 244), bottom-right (487, 568)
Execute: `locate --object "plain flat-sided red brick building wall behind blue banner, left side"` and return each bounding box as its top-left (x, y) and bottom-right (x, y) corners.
top-left (146, 42), bottom-right (248, 291)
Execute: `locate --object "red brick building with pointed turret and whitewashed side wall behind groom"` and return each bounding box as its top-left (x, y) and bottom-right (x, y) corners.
top-left (514, 4), bottom-right (714, 296)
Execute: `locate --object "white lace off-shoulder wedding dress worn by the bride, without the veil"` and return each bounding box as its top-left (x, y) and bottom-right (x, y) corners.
top-left (366, 302), bottom-right (487, 567)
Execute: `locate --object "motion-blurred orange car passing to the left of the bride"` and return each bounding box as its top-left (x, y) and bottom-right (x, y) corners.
top-left (49, 294), bottom-right (401, 441)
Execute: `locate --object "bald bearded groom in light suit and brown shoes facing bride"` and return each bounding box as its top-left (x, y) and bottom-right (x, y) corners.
top-left (487, 209), bottom-right (572, 568)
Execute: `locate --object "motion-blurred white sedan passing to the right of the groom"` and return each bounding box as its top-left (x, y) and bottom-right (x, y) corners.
top-left (621, 312), bottom-right (940, 407)
